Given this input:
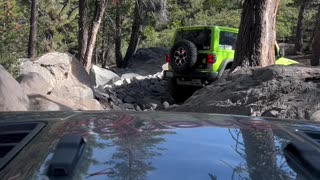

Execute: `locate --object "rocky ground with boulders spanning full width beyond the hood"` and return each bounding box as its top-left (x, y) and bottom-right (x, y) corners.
top-left (0, 48), bottom-right (320, 121)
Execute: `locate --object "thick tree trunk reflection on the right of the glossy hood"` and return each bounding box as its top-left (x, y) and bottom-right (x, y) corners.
top-left (229, 129), bottom-right (296, 180)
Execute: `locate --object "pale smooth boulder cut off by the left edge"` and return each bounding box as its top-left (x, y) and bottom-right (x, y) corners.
top-left (0, 65), bottom-right (29, 111)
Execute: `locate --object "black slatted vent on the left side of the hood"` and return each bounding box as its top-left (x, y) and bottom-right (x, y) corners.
top-left (0, 122), bottom-right (45, 170)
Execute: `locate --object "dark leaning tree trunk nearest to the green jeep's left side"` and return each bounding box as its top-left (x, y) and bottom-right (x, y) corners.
top-left (122, 0), bottom-right (142, 68)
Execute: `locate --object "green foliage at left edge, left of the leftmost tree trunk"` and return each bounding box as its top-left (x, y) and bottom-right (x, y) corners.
top-left (0, 0), bottom-right (29, 74)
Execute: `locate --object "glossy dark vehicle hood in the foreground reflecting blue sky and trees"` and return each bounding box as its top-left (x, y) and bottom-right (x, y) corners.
top-left (0, 111), bottom-right (320, 179)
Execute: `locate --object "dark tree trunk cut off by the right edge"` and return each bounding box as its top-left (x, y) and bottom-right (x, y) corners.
top-left (311, 6), bottom-right (320, 66)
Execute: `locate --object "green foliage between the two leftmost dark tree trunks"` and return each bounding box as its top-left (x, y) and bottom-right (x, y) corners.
top-left (38, 0), bottom-right (78, 54)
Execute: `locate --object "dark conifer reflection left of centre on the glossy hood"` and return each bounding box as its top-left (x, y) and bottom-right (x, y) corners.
top-left (106, 122), bottom-right (174, 180)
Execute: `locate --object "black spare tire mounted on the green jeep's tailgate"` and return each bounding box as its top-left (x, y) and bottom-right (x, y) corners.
top-left (170, 40), bottom-right (198, 73)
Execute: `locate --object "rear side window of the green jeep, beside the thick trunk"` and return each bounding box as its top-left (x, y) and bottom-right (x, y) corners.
top-left (219, 32), bottom-right (237, 50)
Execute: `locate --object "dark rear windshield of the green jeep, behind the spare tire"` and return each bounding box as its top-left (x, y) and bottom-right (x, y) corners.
top-left (176, 30), bottom-right (211, 50)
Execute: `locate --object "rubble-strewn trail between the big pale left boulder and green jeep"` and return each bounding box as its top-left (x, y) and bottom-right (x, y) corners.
top-left (92, 48), bottom-right (175, 111)
